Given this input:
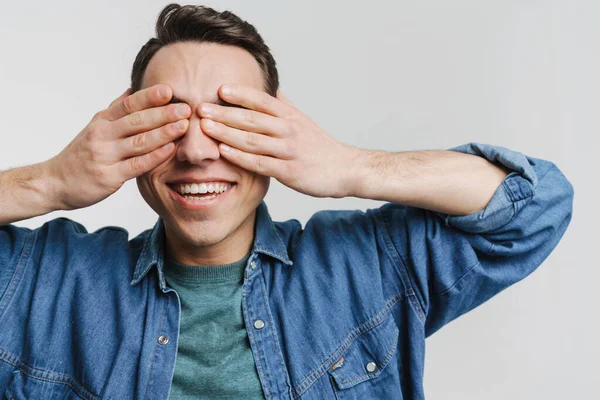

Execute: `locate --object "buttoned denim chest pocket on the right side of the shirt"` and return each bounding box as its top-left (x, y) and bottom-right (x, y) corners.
top-left (327, 315), bottom-right (402, 400)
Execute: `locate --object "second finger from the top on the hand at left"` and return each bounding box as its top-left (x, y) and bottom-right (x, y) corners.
top-left (113, 103), bottom-right (192, 138)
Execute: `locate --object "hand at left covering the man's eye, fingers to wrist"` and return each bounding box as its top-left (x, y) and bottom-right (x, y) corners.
top-left (44, 85), bottom-right (192, 210)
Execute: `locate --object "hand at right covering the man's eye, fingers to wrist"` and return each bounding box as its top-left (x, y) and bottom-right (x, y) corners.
top-left (197, 84), bottom-right (359, 198)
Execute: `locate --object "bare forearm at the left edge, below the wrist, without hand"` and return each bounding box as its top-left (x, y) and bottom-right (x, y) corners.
top-left (0, 163), bottom-right (60, 225)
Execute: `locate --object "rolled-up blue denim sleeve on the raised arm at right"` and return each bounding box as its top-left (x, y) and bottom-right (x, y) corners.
top-left (380, 143), bottom-right (574, 336)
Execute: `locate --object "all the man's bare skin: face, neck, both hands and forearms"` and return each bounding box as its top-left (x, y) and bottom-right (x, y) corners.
top-left (0, 43), bottom-right (510, 258)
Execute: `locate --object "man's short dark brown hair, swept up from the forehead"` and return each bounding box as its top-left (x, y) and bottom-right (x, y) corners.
top-left (131, 4), bottom-right (279, 96)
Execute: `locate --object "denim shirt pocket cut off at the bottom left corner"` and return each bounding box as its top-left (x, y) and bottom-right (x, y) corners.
top-left (4, 370), bottom-right (99, 400)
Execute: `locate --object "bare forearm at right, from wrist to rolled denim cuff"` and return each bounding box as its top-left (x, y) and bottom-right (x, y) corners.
top-left (350, 150), bottom-right (509, 215)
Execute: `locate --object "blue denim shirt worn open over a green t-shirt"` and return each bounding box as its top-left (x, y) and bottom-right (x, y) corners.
top-left (0, 143), bottom-right (574, 400)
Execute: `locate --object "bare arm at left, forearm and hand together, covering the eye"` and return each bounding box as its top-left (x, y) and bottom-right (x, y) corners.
top-left (0, 85), bottom-right (191, 225)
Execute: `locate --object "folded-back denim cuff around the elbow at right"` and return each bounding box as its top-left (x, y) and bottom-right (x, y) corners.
top-left (433, 142), bottom-right (538, 233)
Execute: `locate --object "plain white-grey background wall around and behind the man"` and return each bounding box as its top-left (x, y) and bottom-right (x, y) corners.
top-left (0, 0), bottom-right (600, 400)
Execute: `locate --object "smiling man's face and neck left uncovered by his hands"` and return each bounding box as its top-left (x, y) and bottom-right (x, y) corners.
top-left (137, 42), bottom-right (270, 265)
